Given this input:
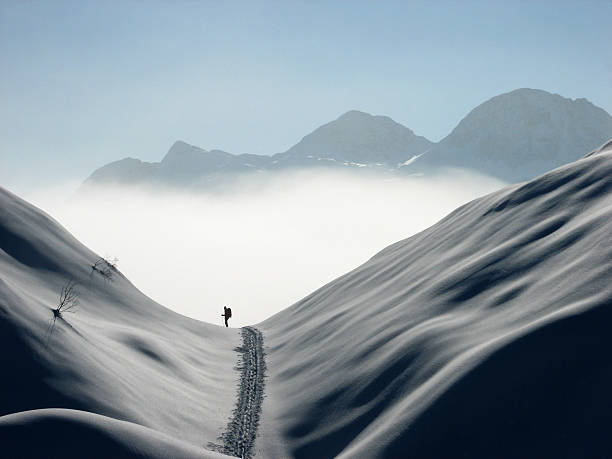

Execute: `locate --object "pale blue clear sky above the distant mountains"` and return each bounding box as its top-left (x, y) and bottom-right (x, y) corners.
top-left (0, 0), bottom-right (612, 192)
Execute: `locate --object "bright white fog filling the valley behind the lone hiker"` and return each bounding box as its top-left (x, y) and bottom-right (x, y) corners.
top-left (26, 172), bottom-right (503, 326)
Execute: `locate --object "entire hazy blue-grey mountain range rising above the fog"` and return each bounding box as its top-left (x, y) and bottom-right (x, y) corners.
top-left (85, 89), bottom-right (612, 187)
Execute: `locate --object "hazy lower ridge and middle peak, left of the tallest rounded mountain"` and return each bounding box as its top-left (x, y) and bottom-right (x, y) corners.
top-left (85, 111), bottom-right (432, 187)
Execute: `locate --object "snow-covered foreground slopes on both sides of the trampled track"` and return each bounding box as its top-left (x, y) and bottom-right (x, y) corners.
top-left (0, 142), bottom-right (612, 458)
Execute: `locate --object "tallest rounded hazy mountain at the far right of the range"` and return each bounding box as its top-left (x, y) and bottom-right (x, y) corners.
top-left (406, 89), bottom-right (612, 182)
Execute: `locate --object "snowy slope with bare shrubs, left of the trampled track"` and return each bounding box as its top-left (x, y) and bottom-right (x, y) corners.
top-left (0, 188), bottom-right (240, 457)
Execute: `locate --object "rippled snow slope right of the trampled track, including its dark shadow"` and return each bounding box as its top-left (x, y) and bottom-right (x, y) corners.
top-left (257, 142), bottom-right (612, 458)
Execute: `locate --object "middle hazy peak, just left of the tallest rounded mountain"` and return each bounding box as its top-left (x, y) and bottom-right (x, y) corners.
top-left (274, 110), bottom-right (433, 168)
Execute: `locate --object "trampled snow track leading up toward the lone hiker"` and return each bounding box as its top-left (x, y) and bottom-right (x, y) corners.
top-left (220, 327), bottom-right (266, 458)
